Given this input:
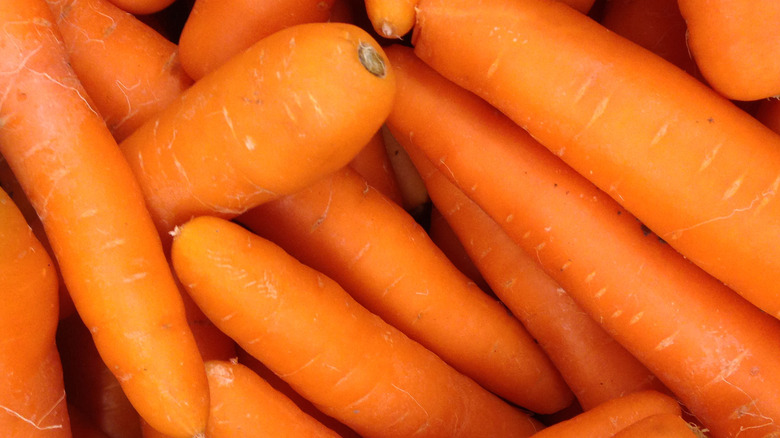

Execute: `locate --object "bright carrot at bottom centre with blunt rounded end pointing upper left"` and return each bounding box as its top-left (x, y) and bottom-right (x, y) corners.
top-left (172, 216), bottom-right (541, 438)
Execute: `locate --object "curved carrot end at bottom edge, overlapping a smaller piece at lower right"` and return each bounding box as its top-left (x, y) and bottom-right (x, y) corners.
top-left (533, 391), bottom-right (680, 438)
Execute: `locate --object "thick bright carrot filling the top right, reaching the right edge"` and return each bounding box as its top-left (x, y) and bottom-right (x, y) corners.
top-left (413, 0), bottom-right (780, 318)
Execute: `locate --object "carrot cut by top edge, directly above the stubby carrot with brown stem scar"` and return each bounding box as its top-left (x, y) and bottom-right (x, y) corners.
top-left (179, 0), bottom-right (334, 79)
